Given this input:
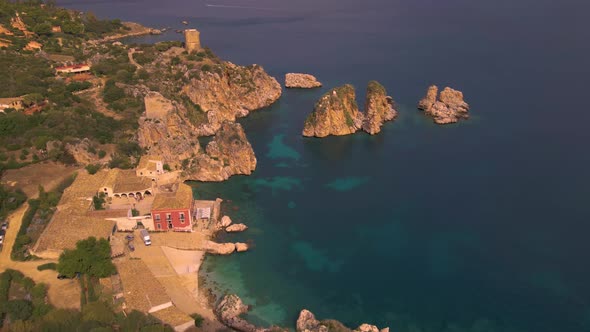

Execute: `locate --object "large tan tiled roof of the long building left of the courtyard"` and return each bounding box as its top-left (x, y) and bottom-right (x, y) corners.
top-left (34, 171), bottom-right (121, 251)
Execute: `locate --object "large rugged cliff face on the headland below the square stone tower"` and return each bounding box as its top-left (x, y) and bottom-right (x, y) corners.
top-left (182, 62), bottom-right (282, 136)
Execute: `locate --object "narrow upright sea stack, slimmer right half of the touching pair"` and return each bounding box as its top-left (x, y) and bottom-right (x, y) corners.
top-left (363, 81), bottom-right (397, 135)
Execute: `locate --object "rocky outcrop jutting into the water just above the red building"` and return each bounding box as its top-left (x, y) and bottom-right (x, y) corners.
top-left (183, 121), bottom-right (256, 181)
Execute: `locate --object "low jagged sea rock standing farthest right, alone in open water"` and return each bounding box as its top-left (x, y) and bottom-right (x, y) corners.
top-left (418, 85), bottom-right (469, 124)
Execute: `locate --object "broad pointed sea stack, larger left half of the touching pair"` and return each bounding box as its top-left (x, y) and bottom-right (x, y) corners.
top-left (303, 84), bottom-right (364, 137)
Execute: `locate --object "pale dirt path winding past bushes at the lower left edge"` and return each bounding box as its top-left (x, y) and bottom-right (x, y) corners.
top-left (0, 203), bottom-right (80, 309)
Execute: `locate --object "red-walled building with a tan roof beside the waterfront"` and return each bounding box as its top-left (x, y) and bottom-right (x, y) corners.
top-left (152, 183), bottom-right (193, 231)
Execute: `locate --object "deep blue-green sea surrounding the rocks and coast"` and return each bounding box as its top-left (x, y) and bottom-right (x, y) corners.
top-left (58, 0), bottom-right (590, 332)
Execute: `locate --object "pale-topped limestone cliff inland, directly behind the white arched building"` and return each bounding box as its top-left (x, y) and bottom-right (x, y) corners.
top-left (137, 92), bottom-right (201, 168)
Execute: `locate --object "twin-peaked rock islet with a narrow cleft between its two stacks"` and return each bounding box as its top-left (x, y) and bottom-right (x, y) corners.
top-left (303, 81), bottom-right (397, 137)
